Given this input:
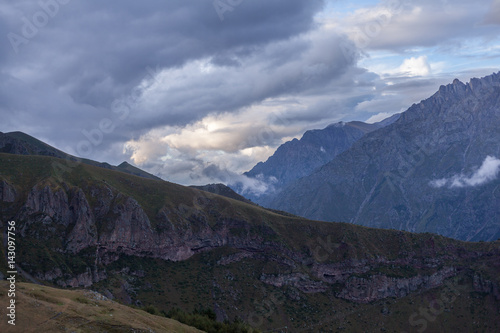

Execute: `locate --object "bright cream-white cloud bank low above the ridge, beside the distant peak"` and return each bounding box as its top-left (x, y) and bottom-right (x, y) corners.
top-left (124, 110), bottom-right (286, 195)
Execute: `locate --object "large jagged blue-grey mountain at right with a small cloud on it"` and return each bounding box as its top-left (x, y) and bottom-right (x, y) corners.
top-left (270, 73), bottom-right (500, 241)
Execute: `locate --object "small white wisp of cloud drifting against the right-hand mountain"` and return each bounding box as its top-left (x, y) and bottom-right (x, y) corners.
top-left (430, 156), bottom-right (500, 188)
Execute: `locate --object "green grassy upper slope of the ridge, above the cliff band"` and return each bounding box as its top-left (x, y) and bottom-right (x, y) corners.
top-left (0, 154), bottom-right (498, 270)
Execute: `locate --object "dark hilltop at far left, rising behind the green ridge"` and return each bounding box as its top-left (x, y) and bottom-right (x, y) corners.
top-left (0, 132), bottom-right (160, 180)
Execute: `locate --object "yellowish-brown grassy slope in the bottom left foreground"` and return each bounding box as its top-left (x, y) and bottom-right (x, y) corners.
top-left (0, 281), bottom-right (202, 333)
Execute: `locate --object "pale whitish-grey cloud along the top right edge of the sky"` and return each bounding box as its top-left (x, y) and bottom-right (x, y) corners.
top-left (338, 0), bottom-right (497, 52)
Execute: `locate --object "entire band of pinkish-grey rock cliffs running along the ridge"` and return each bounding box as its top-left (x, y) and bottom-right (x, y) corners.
top-left (0, 171), bottom-right (498, 303)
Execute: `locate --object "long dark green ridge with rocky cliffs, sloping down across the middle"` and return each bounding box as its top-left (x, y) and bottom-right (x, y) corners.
top-left (0, 153), bottom-right (500, 332)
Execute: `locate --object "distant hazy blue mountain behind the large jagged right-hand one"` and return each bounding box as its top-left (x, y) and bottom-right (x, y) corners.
top-left (245, 114), bottom-right (399, 205)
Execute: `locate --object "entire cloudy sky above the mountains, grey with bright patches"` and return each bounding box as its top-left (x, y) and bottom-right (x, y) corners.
top-left (0, 0), bottom-right (500, 192)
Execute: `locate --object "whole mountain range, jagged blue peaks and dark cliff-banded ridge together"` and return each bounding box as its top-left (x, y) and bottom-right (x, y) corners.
top-left (0, 74), bottom-right (500, 333)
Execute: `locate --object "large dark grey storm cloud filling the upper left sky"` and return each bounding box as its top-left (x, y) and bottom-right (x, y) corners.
top-left (0, 0), bottom-right (323, 153)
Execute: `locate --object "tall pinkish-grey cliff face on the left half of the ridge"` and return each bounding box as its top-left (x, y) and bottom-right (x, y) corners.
top-left (14, 180), bottom-right (272, 261)
